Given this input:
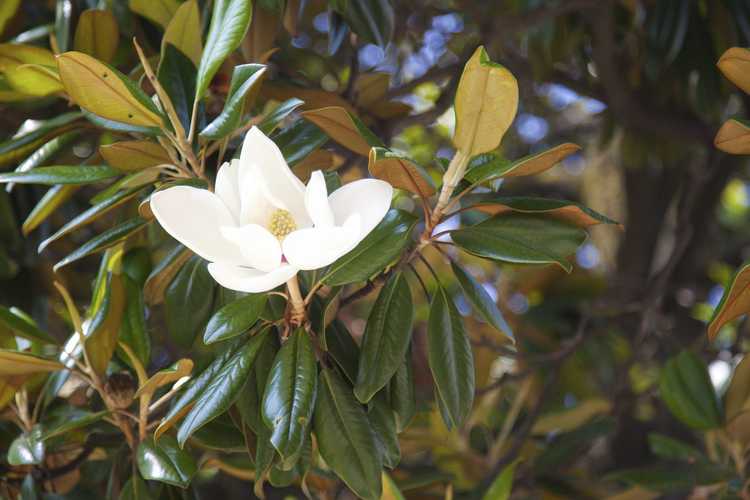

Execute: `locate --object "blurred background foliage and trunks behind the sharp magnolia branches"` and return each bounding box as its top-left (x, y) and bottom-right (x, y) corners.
top-left (7, 0), bottom-right (750, 499)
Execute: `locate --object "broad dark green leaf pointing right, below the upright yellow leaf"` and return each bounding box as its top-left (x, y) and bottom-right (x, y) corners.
top-left (451, 214), bottom-right (587, 272)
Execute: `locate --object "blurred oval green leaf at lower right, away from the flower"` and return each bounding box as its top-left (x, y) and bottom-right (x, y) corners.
top-left (659, 351), bottom-right (723, 429)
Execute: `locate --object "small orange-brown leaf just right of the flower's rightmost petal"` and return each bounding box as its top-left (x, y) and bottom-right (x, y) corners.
top-left (367, 148), bottom-right (435, 198)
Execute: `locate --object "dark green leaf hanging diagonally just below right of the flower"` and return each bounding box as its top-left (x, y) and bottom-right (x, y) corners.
top-left (354, 273), bottom-right (414, 403)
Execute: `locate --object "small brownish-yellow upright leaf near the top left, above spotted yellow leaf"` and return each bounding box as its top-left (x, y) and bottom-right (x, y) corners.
top-left (73, 9), bottom-right (120, 62)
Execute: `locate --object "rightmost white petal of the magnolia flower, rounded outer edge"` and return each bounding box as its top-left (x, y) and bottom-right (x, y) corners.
top-left (328, 179), bottom-right (393, 236)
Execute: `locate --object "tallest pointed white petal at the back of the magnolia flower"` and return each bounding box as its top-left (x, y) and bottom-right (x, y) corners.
top-left (240, 127), bottom-right (309, 226)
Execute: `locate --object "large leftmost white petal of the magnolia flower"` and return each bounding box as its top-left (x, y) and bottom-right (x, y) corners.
top-left (150, 186), bottom-right (245, 264)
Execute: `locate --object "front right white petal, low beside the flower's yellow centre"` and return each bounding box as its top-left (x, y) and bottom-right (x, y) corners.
top-left (281, 214), bottom-right (362, 271)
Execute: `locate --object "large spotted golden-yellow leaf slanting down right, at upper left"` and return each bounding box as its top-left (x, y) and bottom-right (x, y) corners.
top-left (57, 52), bottom-right (162, 127)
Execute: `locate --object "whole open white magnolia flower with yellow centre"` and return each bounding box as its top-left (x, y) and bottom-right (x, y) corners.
top-left (151, 127), bottom-right (393, 293)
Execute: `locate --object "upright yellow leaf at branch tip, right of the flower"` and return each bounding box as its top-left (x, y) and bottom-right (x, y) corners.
top-left (453, 46), bottom-right (518, 156)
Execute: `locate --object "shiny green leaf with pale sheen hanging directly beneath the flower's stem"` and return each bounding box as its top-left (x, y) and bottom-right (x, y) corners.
top-left (262, 328), bottom-right (318, 469)
